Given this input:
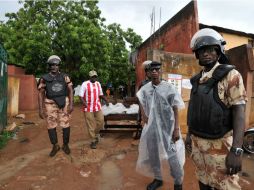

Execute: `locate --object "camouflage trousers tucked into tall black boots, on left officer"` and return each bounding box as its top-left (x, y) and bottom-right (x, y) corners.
top-left (45, 101), bottom-right (70, 129)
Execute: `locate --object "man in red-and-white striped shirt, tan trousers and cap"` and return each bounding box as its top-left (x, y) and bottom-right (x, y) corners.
top-left (79, 70), bottom-right (108, 149)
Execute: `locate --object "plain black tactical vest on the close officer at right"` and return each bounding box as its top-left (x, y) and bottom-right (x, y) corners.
top-left (187, 64), bottom-right (234, 139)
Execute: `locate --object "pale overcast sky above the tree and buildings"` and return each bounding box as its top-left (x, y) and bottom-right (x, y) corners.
top-left (0, 0), bottom-right (254, 40)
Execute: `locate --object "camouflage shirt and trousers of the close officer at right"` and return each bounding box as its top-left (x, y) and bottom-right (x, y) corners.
top-left (191, 63), bottom-right (247, 190)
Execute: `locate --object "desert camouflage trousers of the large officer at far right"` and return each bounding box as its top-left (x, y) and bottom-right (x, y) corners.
top-left (191, 131), bottom-right (241, 190)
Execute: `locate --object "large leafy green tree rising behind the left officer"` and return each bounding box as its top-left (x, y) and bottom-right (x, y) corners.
top-left (0, 0), bottom-right (142, 89)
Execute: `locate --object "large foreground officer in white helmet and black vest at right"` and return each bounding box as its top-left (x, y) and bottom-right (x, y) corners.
top-left (186, 28), bottom-right (247, 190)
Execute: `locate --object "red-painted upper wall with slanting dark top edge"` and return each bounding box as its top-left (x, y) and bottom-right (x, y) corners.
top-left (136, 1), bottom-right (199, 90)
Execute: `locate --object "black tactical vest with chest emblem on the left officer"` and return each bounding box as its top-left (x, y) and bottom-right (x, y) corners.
top-left (42, 73), bottom-right (68, 108)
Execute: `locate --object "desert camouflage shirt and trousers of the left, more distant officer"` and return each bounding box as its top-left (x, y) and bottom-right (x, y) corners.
top-left (38, 76), bottom-right (72, 129)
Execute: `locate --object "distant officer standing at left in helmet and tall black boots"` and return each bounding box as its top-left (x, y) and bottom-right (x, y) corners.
top-left (38, 55), bottom-right (73, 157)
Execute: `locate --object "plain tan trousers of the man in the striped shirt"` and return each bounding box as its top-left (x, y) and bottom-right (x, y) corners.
top-left (84, 110), bottom-right (104, 141)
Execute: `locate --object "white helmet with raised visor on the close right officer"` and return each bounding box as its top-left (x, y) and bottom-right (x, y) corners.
top-left (190, 28), bottom-right (228, 64)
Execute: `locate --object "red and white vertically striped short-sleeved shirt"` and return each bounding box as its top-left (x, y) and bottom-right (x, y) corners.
top-left (79, 81), bottom-right (103, 112)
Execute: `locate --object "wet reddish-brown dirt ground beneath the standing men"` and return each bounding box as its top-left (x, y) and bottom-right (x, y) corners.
top-left (0, 106), bottom-right (254, 190)
